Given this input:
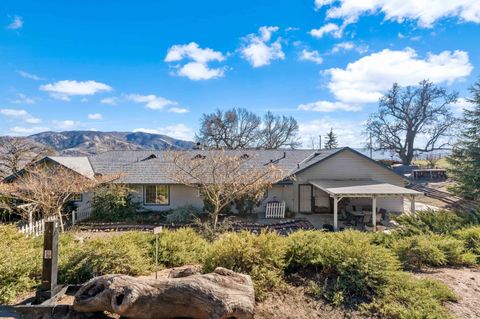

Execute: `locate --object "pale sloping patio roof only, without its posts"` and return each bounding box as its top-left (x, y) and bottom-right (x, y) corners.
top-left (309, 179), bottom-right (423, 197)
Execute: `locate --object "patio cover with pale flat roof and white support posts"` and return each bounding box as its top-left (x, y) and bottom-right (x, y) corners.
top-left (309, 179), bottom-right (423, 231)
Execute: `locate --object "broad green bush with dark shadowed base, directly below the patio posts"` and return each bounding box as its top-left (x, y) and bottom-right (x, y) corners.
top-left (286, 231), bottom-right (399, 304)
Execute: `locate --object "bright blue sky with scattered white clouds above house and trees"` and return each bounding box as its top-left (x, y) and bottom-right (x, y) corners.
top-left (0, 0), bottom-right (480, 147)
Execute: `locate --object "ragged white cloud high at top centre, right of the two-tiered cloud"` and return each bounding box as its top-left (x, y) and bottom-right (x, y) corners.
top-left (240, 26), bottom-right (285, 68)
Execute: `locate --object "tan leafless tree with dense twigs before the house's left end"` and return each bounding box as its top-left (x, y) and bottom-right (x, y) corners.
top-left (0, 164), bottom-right (116, 231)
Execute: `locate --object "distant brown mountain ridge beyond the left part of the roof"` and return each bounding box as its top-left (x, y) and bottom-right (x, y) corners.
top-left (4, 131), bottom-right (195, 156)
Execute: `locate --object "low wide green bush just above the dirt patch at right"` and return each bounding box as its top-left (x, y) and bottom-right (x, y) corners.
top-left (393, 235), bottom-right (475, 269)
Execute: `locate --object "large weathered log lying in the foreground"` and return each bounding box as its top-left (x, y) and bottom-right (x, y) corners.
top-left (73, 268), bottom-right (255, 319)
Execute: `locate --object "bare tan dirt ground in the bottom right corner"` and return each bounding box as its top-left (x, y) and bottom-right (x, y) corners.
top-left (417, 268), bottom-right (480, 319)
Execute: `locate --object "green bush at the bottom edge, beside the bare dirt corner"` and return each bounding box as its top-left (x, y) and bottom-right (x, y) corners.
top-left (362, 272), bottom-right (456, 319)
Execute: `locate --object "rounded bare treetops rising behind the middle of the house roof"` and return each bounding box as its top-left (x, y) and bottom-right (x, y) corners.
top-left (196, 108), bottom-right (299, 149)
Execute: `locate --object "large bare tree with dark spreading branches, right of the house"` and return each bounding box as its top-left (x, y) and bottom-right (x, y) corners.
top-left (366, 80), bottom-right (457, 165)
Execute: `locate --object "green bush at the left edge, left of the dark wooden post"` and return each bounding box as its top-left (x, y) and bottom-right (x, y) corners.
top-left (0, 226), bottom-right (42, 304)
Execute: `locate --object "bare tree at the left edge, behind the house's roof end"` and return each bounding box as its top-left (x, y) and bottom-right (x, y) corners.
top-left (0, 136), bottom-right (53, 178)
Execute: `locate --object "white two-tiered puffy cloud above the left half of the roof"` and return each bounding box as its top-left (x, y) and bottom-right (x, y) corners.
top-left (164, 42), bottom-right (225, 81)
